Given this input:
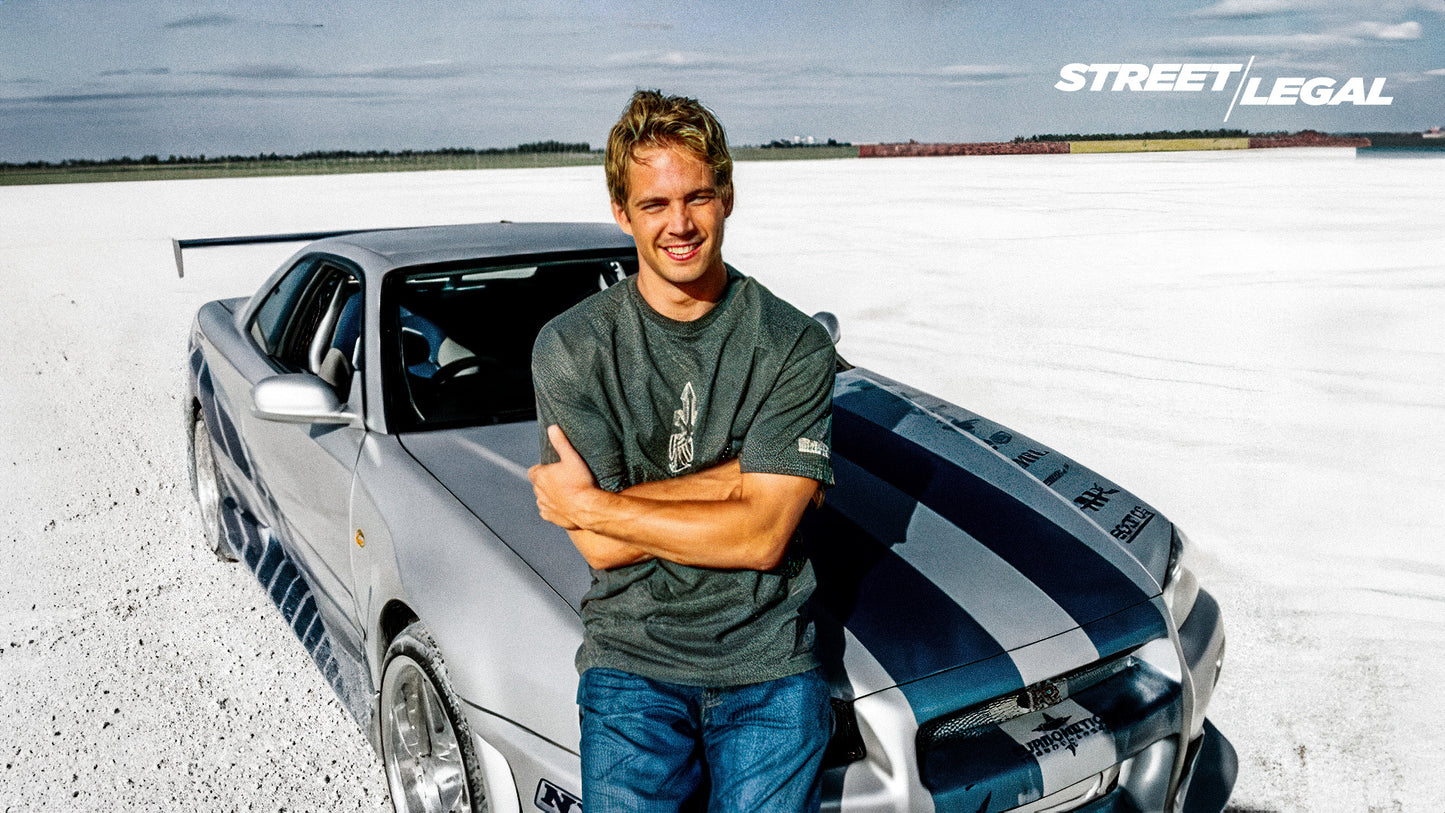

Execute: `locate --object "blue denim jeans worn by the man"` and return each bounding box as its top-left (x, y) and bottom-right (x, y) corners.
top-left (577, 667), bottom-right (832, 813)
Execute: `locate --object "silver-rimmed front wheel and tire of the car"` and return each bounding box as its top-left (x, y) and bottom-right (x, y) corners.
top-left (379, 622), bottom-right (488, 813)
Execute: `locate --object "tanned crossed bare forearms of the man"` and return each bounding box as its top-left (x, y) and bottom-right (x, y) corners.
top-left (527, 425), bottom-right (818, 570)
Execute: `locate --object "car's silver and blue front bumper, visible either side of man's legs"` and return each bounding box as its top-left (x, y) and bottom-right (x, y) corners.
top-left (439, 591), bottom-right (1238, 813)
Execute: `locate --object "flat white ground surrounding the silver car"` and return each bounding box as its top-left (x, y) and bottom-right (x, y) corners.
top-left (0, 150), bottom-right (1445, 812)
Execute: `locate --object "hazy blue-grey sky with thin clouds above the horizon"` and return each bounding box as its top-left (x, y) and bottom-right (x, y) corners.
top-left (0, 0), bottom-right (1445, 162)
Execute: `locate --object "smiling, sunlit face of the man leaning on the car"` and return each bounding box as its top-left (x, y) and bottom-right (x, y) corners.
top-left (613, 146), bottom-right (733, 321)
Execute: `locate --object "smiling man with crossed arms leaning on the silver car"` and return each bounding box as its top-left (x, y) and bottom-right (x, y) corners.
top-left (532, 91), bottom-right (835, 813)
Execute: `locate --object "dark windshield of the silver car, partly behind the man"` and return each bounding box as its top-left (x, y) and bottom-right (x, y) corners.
top-left (381, 254), bottom-right (637, 432)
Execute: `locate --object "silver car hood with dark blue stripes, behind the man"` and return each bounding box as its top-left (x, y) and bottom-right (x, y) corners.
top-left (402, 368), bottom-right (1170, 696)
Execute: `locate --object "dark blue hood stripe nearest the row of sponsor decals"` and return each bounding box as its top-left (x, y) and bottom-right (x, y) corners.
top-left (832, 387), bottom-right (1149, 624)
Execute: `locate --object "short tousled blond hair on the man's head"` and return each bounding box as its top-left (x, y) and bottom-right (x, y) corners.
top-left (605, 91), bottom-right (733, 208)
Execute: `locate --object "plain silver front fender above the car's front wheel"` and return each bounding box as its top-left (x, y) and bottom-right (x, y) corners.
top-left (353, 435), bottom-right (582, 749)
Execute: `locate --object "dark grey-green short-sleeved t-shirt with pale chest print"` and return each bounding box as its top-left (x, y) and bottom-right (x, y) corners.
top-left (532, 269), bottom-right (837, 687)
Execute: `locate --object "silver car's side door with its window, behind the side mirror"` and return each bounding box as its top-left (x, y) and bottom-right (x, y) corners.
top-left (237, 256), bottom-right (366, 653)
